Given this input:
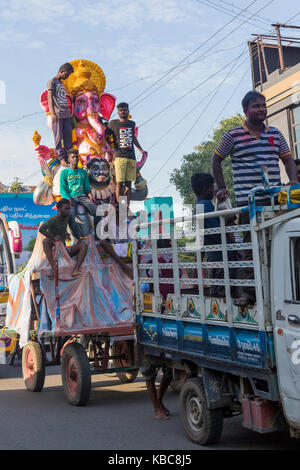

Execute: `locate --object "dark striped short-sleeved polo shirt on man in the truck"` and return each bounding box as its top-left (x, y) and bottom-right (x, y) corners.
top-left (216, 123), bottom-right (291, 206)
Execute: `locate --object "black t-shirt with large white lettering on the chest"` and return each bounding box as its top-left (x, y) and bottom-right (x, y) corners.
top-left (108, 119), bottom-right (135, 160)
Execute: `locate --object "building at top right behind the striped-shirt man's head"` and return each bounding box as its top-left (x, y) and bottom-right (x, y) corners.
top-left (248, 23), bottom-right (300, 182)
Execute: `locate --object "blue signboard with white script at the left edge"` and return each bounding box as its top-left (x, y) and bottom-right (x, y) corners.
top-left (0, 193), bottom-right (57, 250)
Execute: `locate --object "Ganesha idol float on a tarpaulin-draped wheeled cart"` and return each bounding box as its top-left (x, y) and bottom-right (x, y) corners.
top-left (6, 60), bottom-right (148, 405)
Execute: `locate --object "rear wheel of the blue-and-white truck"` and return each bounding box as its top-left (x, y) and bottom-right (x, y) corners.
top-left (180, 378), bottom-right (223, 445)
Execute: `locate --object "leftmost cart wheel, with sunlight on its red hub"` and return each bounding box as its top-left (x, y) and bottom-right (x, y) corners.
top-left (22, 341), bottom-right (45, 392)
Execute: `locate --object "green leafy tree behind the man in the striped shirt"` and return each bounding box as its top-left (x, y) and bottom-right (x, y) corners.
top-left (170, 114), bottom-right (244, 205)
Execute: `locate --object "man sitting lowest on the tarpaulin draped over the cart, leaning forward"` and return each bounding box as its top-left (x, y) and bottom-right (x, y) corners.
top-left (39, 199), bottom-right (87, 279)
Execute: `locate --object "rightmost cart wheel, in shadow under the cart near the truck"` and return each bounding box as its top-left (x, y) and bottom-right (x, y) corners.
top-left (112, 340), bottom-right (139, 383)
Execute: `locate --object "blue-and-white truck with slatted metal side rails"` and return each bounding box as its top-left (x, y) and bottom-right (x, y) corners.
top-left (133, 186), bottom-right (300, 445)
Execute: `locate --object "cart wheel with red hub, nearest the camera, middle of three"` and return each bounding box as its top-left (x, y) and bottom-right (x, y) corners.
top-left (61, 343), bottom-right (91, 406)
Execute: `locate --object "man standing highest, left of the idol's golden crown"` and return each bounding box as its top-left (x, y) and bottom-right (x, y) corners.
top-left (47, 63), bottom-right (74, 166)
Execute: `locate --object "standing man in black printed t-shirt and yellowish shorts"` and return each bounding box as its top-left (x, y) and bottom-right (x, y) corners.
top-left (108, 103), bottom-right (144, 206)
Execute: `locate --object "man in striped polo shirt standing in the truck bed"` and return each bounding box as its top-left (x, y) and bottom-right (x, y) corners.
top-left (212, 91), bottom-right (298, 307)
